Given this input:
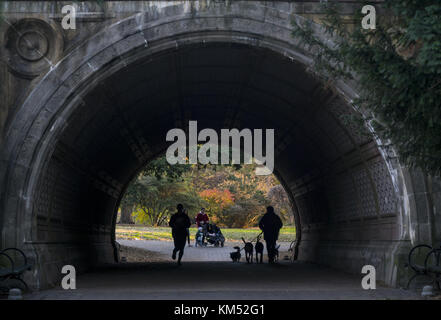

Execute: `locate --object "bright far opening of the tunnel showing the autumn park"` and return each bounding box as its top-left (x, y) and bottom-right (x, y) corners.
top-left (115, 149), bottom-right (296, 263)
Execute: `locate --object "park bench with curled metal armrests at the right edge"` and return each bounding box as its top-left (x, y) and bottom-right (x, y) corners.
top-left (406, 244), bottom-right (441, 290)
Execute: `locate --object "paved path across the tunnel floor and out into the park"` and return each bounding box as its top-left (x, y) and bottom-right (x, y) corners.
top-left (25, 241), bottom-right (419, 300)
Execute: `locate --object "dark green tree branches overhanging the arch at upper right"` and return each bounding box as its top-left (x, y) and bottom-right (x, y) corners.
top-left (293, 0), bottom-right (441, 175)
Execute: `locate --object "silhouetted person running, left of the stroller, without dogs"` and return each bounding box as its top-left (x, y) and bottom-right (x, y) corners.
top-left (168, 204), bottom-right (191, 265)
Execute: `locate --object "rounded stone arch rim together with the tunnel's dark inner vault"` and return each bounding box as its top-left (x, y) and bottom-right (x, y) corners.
top-left (0, 5), bottom-right (409, 287)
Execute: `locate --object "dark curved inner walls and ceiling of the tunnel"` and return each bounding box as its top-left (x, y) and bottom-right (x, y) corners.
top-left (0, 34), bottom-right (401, 287)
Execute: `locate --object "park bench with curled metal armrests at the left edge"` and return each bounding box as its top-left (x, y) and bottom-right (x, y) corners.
top-left (0, 248), bottom-right (32, 292)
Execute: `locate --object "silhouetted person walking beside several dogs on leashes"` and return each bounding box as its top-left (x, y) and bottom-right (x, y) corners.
top-left (259, 206), bottom-right (283, 263)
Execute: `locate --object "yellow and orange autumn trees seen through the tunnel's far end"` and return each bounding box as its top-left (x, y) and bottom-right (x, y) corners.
top-left (121, 157), bottom-right (289, 228)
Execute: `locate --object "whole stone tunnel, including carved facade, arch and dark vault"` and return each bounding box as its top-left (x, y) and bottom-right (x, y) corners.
top-left (0, 1), bottom-right (441, 288)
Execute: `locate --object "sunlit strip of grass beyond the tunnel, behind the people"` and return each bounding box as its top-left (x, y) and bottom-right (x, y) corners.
top-left (116, 225), bottom-right (296, 241)
